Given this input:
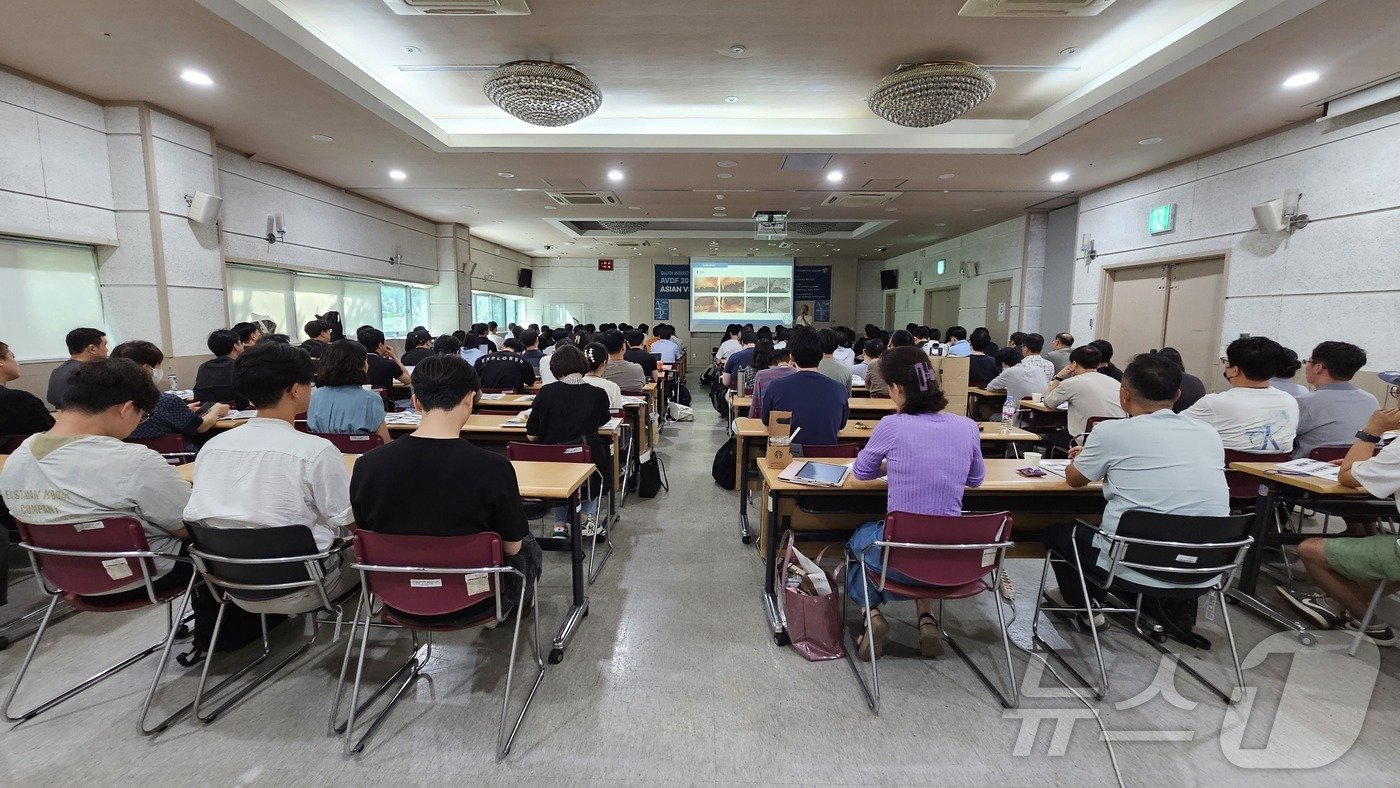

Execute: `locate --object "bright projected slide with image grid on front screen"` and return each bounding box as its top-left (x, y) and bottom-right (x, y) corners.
top-left (690, 258), bottom-right (792, 332)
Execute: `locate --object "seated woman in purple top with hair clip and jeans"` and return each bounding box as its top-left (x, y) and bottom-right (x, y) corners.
top-left (846, 347), bottom-right (986, 661)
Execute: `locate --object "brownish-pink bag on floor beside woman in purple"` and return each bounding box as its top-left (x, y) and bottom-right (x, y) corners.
top-left (778, 530), bottom-right (846, 662)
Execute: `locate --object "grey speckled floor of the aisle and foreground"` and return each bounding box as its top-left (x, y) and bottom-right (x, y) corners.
top-left (0, 417), bottom-right (1400, 787)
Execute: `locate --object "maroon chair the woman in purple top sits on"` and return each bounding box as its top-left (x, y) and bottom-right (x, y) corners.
top-left (841, 512), bottom-right (1021, 714)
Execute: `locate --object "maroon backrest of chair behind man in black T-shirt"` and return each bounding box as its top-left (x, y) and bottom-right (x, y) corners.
top-left (354, 529), bottom-right (505, 616)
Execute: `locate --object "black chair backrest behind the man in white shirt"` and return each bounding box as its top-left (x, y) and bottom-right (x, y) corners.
top-left (186, 522), bottom-right (321, 600)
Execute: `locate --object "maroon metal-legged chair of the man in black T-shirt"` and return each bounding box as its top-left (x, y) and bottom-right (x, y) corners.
top-left (330, 530), bottom-right (545, 761)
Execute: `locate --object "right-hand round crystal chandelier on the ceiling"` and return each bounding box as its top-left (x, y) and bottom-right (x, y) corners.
top-left (865, 60), bottom-right (997, 129)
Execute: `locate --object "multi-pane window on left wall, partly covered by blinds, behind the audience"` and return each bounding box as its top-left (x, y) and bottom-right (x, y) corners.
top-left (228, 265), bottom-right (428, 342)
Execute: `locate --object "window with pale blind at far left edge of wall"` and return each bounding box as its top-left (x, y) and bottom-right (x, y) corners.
top-left (0, 237), bottom-right (106, 361)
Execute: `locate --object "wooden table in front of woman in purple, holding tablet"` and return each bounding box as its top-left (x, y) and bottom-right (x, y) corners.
top-left (759, 459), bottom-right (1103, 645)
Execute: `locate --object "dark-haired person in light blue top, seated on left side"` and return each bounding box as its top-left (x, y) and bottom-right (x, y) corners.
top-left (307, 339), bottom-right (389, 444)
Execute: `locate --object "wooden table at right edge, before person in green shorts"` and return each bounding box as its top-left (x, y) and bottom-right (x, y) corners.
top-left (1226, 462), bottom-right (1377, 645)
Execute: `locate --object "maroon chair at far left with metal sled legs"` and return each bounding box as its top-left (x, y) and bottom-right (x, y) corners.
top-left (4, 516), bottom-right (196, 736)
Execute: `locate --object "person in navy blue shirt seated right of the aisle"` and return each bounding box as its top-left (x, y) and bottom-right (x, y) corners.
top-left (759, 326), bottom-right (851, 445)
